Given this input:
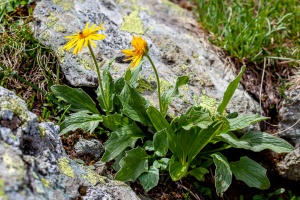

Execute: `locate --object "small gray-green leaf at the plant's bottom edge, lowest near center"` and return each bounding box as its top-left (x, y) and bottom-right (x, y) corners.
top-left (139, 166), bottom-right (159, 192)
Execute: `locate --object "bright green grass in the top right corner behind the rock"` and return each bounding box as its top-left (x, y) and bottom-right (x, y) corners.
top-left (194, 0), bottom-right (300, 66)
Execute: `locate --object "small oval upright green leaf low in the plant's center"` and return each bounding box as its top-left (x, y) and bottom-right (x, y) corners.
top-left (153, 129), bottom-right (169, 156)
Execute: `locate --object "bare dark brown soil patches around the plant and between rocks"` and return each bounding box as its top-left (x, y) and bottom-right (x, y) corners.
top-left (1, 0), bottom-right (300, 200)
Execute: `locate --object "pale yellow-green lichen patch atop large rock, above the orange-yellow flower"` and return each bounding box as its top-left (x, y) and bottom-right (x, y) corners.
top-left (120, 10), bottom-right (145, 34)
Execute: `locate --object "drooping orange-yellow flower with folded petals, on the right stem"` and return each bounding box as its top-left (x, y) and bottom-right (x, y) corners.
top-left (122, 35), bottom-right (148, 69)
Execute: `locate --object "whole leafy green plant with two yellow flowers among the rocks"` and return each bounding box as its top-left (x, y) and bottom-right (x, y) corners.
top-left (51, 21), bottom-right (293, 196)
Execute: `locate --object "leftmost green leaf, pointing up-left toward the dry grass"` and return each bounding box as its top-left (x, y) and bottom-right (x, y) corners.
top-left (51, 85), bottom-right (100, 114)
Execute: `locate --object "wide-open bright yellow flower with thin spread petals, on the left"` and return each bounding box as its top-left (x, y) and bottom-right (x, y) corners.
top-left (63, 22), bottom-right (106, 54)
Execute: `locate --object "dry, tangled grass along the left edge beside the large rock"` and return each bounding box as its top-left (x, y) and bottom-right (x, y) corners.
top-left (0, 1), bottom-right (63, 120)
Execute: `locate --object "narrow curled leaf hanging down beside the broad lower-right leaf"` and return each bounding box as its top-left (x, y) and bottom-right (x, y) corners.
top-left (211, 153), bottom-right (232, 196)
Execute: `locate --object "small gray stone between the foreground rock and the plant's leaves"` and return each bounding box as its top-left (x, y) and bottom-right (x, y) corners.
top-left (75, 138), bottom-right (105, 158)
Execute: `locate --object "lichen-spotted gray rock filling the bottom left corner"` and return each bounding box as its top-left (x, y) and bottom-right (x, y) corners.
top-left (0, 87), bottom-right (138, 200)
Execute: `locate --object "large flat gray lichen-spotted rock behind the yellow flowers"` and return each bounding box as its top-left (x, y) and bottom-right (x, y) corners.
top-left (33, 0), bottom-right (258, 114)
